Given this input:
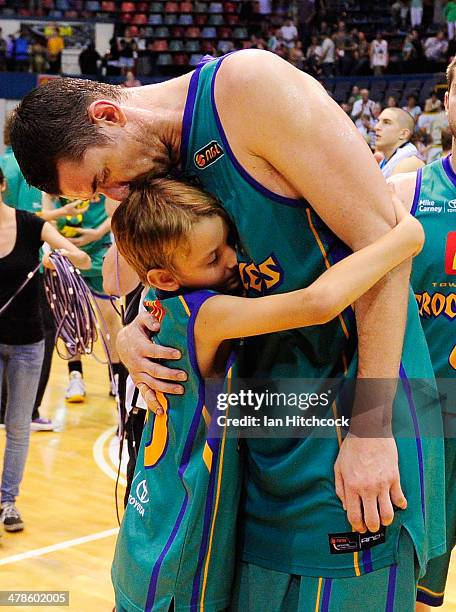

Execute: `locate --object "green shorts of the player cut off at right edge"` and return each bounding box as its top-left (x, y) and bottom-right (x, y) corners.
top-left (416, 414), bottom-right (456, 606)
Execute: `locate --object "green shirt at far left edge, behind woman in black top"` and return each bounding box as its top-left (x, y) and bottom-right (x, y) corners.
top-left (0, 147), bottom-right (41, 213)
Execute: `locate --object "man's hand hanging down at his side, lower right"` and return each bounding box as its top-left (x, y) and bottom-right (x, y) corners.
top-left (334, 434), bottom-right (407, 533)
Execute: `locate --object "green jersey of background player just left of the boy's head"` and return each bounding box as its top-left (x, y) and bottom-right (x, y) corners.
top-left (55, 195), bottom-right (111, 277)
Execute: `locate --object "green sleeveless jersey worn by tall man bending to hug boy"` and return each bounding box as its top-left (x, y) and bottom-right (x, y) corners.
top-left (181, 52), bottom-right (445, 577)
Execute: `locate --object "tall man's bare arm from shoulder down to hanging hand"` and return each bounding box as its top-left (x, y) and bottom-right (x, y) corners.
top-left (219, 52), bottom-right (416, 531)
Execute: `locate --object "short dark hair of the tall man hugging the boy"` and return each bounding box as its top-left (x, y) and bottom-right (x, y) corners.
top-left (10, 78), bottom-right (124, 193)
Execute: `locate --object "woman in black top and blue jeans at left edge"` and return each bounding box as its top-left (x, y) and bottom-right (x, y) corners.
top-left (0, 170), bottom-right (91, 531)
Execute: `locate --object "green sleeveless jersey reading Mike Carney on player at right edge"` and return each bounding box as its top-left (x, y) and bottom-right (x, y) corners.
top-left (411, 157), bottom-right (456, 392)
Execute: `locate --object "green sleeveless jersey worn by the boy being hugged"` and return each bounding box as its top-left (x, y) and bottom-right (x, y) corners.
top-left (112, 291), bottom-right (241, 612)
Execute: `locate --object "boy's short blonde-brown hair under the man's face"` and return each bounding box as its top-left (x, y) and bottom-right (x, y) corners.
top-left (111, 179), bottom-right (229, 283)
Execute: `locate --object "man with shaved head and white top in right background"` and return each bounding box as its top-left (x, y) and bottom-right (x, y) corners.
top-left (375, 108), bottom-right (424, 178)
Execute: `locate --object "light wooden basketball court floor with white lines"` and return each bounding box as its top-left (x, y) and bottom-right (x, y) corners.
top-left (0, 357), bottom-right (456, 612)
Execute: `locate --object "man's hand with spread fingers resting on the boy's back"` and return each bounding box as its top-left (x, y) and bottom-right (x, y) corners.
top-left (116, 312), bottom-right (187, 414)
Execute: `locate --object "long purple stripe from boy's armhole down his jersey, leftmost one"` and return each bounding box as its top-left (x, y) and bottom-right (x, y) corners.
top-left (146, 291), bottom-right (214, 612)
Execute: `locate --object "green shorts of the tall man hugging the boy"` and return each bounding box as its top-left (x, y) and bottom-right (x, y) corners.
top-left (230, 531), bottom-right (419, 612)
